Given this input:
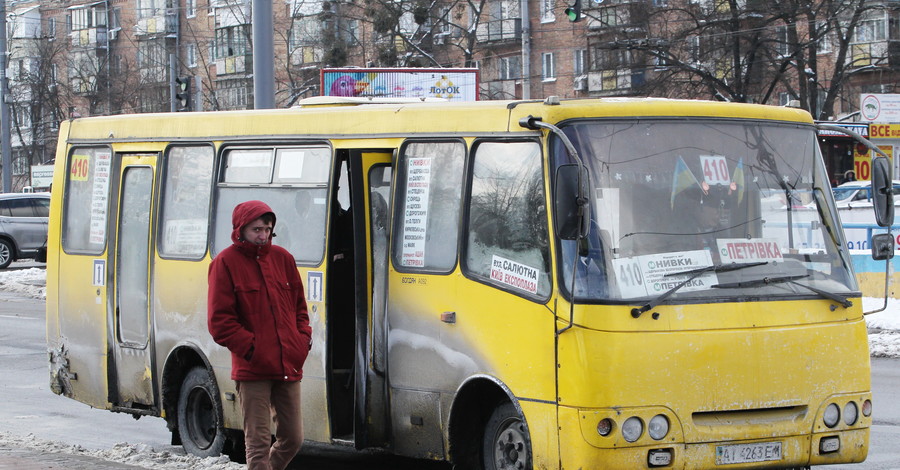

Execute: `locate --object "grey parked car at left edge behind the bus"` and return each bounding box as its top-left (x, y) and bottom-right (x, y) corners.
top-left (0, 193), bottom-right (50, 269)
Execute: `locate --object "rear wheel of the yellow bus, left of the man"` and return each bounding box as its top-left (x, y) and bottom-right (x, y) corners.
top-left (178, 367), bottom-right (226, 457)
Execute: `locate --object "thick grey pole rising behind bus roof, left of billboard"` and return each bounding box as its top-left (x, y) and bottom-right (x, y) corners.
top-left (250, 0), bottom-right (275, 109)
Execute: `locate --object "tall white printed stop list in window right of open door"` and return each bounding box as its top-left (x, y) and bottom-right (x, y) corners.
top-left (401, 158), bottom-right (431, 267)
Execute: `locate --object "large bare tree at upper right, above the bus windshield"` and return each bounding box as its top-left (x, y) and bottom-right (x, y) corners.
top-left (589, 0), bottom-right (885, 119)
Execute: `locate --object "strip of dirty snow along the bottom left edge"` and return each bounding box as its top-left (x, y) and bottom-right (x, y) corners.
top-left (0, 431), bottom-right (246, 470)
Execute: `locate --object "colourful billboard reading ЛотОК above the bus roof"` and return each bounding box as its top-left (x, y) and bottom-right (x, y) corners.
top-left (320, 68), bottom-right (478, 101)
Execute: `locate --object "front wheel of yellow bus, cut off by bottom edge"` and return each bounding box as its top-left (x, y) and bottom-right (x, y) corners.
top-left (482, 402), bottom-right (531, 470)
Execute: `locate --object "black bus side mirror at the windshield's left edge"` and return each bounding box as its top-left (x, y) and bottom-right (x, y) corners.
top-left (553, 163), bottom-right (591, 240)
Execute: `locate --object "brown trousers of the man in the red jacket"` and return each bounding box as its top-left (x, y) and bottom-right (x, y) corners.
top-left (237, 380), bottom-right (303, 470)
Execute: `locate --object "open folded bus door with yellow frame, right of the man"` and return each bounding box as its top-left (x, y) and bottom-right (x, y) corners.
top-left (342, 152), bottom-right (393, 449)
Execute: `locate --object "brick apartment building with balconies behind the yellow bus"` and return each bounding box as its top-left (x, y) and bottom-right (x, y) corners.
top-left (7, 0), bottom-right (900, 189)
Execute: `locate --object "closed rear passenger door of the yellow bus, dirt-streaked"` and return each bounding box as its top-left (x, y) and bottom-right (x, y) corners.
top-left (108, 154), bottom-right (157, 409)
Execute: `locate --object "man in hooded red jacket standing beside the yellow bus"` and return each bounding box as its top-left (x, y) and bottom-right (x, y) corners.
top-left (207, 201), bottom-right (312, 470)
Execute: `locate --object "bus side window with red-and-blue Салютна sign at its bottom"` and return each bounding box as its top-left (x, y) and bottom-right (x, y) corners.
top-left (465, 142), bottom-right (550, 297)
